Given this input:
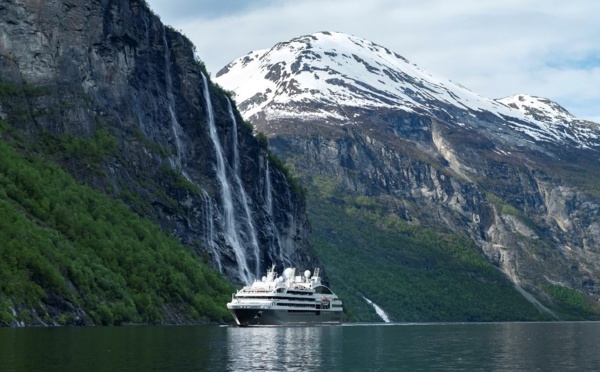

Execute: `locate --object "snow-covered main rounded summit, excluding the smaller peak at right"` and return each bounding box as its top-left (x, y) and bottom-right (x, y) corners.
top-left (217, 32), bottom-right (510, 119)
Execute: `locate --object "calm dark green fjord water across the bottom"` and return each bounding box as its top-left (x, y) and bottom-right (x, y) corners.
top-left (0, 323), bottom-right (600, 371)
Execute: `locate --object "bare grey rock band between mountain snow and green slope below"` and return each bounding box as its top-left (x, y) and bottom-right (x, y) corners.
top-left (270, 107), bottom-right (600, 306)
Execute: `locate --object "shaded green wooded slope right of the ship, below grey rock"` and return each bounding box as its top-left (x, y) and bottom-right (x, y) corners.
top-left (308, 182), bottom-right (548, 321)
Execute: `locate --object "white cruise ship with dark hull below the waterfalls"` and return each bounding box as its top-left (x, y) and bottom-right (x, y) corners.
top-left (227, 266), bottom-right (343, 326)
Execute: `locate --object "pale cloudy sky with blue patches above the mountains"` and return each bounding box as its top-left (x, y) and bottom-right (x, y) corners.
top-left (147, 0), bottom-right (600, 123)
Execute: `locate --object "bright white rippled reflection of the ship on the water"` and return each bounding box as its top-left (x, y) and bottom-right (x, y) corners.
top-left (227, 326), bottom-right (341, 371)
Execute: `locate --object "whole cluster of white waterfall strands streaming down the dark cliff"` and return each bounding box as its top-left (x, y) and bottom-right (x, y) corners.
top-left (152, 71), bottom-right (296, 284)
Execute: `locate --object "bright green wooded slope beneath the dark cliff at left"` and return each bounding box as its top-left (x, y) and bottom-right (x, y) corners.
top-left (0, 140), bottom-right (233, 325)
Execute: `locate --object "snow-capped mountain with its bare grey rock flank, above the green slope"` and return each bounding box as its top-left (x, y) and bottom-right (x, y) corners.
top-left (217, 32), bottom-right (600, 306)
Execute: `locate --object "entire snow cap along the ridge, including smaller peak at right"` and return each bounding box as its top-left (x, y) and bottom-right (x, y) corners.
top-left (216, 32), bottom-right (600, 147)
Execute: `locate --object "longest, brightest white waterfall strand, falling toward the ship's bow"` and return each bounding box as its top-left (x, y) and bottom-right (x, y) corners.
top-left (202, 74), bottom-right (253, 284)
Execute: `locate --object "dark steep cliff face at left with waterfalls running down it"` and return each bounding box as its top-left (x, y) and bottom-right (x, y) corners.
top-left (0, 0), bottom-right (315, 282)
